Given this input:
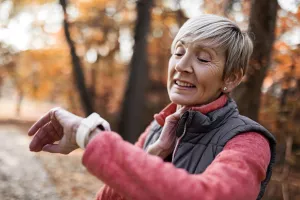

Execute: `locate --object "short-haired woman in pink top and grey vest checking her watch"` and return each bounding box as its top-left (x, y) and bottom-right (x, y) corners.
top-left (29, 15), bottom-right (276, 200)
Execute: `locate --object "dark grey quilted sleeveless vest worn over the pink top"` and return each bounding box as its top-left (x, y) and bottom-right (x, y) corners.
top-left (144, 99), bottom-right (276, 199)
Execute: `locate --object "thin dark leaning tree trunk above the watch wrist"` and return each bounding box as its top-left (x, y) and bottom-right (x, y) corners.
top-left (59, 0), bottom-right (94, 115)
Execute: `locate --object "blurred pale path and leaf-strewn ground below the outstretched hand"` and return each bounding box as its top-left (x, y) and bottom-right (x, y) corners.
top-left (0, 122), bottom-right (102, 200)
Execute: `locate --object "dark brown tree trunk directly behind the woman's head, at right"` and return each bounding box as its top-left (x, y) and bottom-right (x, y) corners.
top-left (233, 0), bottom-right (278, 120)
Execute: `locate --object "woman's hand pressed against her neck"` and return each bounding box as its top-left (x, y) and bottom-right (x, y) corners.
top-left (147, 106), bottom-right (188, 159)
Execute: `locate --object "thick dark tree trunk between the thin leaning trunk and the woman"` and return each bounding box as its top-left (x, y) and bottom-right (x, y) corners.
top-left (119, 0), bottom-right (152, 142)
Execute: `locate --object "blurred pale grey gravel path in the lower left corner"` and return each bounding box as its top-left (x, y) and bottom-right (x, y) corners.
top-left (0, 125), bottom-right (60, 200)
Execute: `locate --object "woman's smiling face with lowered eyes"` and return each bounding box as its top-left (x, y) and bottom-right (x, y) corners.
top-left (168, 40), bottom-right (225, 106)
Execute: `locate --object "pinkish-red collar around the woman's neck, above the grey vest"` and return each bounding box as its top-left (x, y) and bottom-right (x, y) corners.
top-left (154, 94), bottom-right (228, 126)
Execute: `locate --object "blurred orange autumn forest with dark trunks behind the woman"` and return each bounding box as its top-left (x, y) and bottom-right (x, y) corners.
top-left (0, 0), bottom-right (300, 200)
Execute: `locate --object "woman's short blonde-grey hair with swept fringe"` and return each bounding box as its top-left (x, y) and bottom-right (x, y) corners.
top-left (171, 14), bottom-right (253, 78)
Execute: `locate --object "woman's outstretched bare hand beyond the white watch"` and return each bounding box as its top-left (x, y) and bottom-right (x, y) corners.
top-left (28, 108), bottom-right (83, 154)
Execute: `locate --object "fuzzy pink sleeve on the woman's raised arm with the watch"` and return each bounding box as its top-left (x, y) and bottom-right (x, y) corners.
top-left (83, 132), bottom-right (270, 200)
